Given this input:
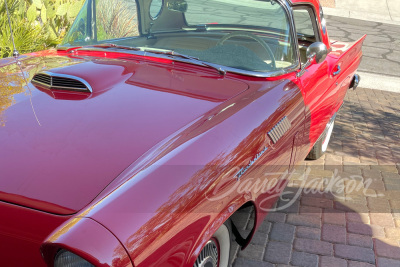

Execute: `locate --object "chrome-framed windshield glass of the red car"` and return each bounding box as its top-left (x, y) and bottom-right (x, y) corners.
top-left (62, 0), bottom-right (297, 73)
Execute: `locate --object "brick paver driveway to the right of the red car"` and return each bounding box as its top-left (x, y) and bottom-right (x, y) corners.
top-left (233, 89), bottom-right (400, 267)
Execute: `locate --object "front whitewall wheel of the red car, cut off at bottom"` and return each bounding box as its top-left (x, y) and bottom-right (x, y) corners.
top-left (193, 224), bottom-right (231, 267)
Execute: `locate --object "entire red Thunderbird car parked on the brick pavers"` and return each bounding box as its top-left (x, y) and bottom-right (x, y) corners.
top-left (0, 0), bottom-right (365, 267)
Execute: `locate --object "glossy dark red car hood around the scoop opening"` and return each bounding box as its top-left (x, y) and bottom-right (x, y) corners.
top-left (0, 51), bottom-right (248, 214)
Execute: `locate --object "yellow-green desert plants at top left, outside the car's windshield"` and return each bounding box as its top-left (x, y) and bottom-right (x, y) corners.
top-left (0, 0), bottom-right (84, 58)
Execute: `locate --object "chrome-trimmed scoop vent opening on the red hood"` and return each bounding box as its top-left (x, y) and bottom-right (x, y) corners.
top-left (32, 72), bottom-right (93, 92)
